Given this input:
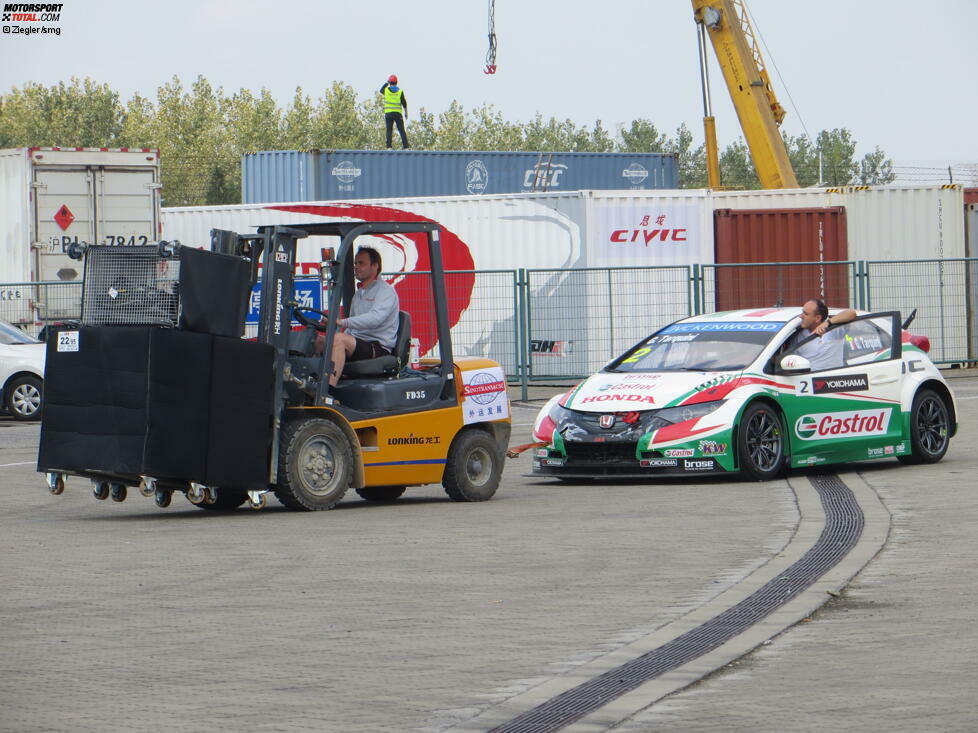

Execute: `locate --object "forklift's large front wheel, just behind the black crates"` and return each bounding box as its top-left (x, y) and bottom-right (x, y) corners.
top-left (275, 418), bottom-right (353, 511)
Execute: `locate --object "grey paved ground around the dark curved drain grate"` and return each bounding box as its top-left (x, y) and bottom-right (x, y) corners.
top-left (0, 371), bottom-right (978, 733)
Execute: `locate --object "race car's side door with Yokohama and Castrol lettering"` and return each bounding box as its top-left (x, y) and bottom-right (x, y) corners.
top-left (777, 313), bottom-right (906, 466)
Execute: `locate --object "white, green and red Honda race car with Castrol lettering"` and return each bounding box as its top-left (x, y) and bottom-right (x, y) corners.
top-left (533, 308), bottom-right (957, 480)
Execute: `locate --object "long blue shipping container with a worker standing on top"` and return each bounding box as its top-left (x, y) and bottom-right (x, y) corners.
top-left (241, 150), bottom-right (679, 204)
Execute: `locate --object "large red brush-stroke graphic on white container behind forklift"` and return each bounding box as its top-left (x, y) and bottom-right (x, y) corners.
top-left (268, 204), bottom-right (475, 355)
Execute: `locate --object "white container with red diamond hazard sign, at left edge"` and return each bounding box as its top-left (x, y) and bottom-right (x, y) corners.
top-left (0, 148), bottom-right (160, 283)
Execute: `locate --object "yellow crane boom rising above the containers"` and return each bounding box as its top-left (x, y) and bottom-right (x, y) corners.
top-left (692, 0), bottom-right (798, 188)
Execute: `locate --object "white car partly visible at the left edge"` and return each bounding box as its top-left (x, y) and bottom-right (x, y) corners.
top-left (0, 321), bottom-right (46, 420)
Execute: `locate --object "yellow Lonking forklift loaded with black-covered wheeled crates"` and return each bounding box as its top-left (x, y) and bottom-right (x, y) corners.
top-left (38, 222), bottom-right (511, 510)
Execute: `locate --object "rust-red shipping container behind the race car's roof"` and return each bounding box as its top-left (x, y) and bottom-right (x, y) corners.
top-left (713, 206), bottom-right (850, 311)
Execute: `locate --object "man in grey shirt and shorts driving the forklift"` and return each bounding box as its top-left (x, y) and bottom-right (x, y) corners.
top-left (318, 247), bottom-right (401, 387)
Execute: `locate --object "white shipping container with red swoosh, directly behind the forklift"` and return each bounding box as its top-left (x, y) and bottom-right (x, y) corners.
top-left (163, 192), bottom-right (586, 373)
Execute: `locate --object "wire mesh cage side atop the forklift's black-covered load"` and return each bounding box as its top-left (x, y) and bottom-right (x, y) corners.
top-left (81, 245), bottom-right (180, 328)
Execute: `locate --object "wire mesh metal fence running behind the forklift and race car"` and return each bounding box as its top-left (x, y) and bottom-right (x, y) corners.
top-left (0, 258), bottom-right (978, 387)
